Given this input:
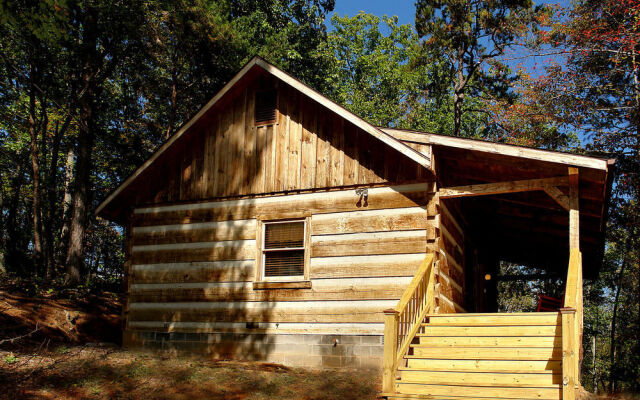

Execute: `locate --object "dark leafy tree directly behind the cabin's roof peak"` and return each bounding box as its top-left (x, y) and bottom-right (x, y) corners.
top-left (138, 0), bottom-right (334, 143)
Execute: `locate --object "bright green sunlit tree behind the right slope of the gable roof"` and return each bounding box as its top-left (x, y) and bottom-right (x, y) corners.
top-left (323, 12), bottom-right (446, 131)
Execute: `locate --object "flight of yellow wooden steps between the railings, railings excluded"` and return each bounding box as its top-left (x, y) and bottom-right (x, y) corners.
top-left (388, 312), bottom-right (562, 399)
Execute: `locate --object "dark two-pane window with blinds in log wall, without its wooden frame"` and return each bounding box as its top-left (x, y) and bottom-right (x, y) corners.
top-left (262, 221), bottom-right (305, 278)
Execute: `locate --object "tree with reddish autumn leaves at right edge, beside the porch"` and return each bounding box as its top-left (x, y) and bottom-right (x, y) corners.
top-left (504, 0), bottom-right (640, 392)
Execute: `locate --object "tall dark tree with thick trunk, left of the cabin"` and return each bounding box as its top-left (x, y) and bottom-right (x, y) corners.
top-left (59, 0), bottom-right (144, 284)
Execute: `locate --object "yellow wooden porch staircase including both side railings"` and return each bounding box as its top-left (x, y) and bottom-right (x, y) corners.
top-left (380, 250), bottom-right (582, 400)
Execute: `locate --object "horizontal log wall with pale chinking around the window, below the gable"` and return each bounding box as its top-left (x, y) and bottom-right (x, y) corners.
top-left (122, 183), bottom-right (436, 365)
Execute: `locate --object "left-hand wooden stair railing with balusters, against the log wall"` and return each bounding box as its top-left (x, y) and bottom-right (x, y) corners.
top-left (382, 254), bottom-right (435, 393)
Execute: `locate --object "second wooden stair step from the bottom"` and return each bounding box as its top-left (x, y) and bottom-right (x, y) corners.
top-left (400, 369), bottom-right (562, 387)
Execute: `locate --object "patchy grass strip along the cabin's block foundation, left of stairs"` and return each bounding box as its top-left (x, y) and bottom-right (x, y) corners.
top-left (0, 346), bottom-right (380, 400)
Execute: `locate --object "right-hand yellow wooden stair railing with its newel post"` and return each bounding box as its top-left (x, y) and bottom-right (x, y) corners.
top-left (560, 249), bottom-right (584, 400)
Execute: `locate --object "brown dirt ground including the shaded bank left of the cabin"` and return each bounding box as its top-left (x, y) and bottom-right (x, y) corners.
top-left (0, 286), bottom-right (380, 400)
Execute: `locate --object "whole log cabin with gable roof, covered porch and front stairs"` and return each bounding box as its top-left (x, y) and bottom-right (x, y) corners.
top-left (96, 57), bottom-right (614, 399)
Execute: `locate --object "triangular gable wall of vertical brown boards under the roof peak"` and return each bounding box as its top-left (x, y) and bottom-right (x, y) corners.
top-left (134, 77), bottom-right (429, 204)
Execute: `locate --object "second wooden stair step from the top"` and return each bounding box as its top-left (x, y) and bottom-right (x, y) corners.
top-left (417, 323), bottom-right (561, 337)
